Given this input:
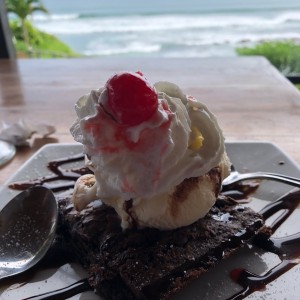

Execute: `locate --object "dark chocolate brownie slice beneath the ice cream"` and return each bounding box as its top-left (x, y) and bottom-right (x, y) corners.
top-left (59, 196), bottom-right (264, 299)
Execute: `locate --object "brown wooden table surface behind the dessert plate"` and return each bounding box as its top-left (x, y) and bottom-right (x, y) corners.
top-left (0, 57), bottom-right (300, 184)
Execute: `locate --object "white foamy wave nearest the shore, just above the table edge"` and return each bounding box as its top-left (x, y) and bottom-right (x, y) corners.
top-left (79, 32), bottom-right (300, 57)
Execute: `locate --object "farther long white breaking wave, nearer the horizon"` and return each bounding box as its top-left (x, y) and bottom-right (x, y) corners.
top-left (34, 11), bottom-right (300, 34)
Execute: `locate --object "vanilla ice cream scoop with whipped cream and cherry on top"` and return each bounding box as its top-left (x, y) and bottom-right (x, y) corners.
top-left (71, 72), bottom-right (230, 229)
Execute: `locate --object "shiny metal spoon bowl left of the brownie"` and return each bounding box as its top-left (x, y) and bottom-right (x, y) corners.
top-left (0, 186), bottom-right (58, 279)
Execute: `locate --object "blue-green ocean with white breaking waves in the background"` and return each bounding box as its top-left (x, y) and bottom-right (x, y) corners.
top-left (32, 0), bottom-right (300, 57)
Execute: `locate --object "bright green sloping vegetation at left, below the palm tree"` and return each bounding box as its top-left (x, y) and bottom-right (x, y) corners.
top-left (10, 20), bottom-right (79, 58)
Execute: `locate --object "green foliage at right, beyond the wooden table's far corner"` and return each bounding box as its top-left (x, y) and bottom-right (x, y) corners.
top-left (236, 41), bottom-right (300, 75)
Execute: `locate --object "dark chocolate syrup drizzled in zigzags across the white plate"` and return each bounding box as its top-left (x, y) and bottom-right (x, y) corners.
top-left (5, 155), bottom-right (300, 300)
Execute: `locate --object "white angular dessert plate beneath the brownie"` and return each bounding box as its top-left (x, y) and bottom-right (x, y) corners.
top-left (0, 142), bottom-right (300, 300)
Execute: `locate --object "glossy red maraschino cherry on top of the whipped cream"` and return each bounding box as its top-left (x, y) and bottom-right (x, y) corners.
top-left (106, 72), bottom-right (158, 126)
